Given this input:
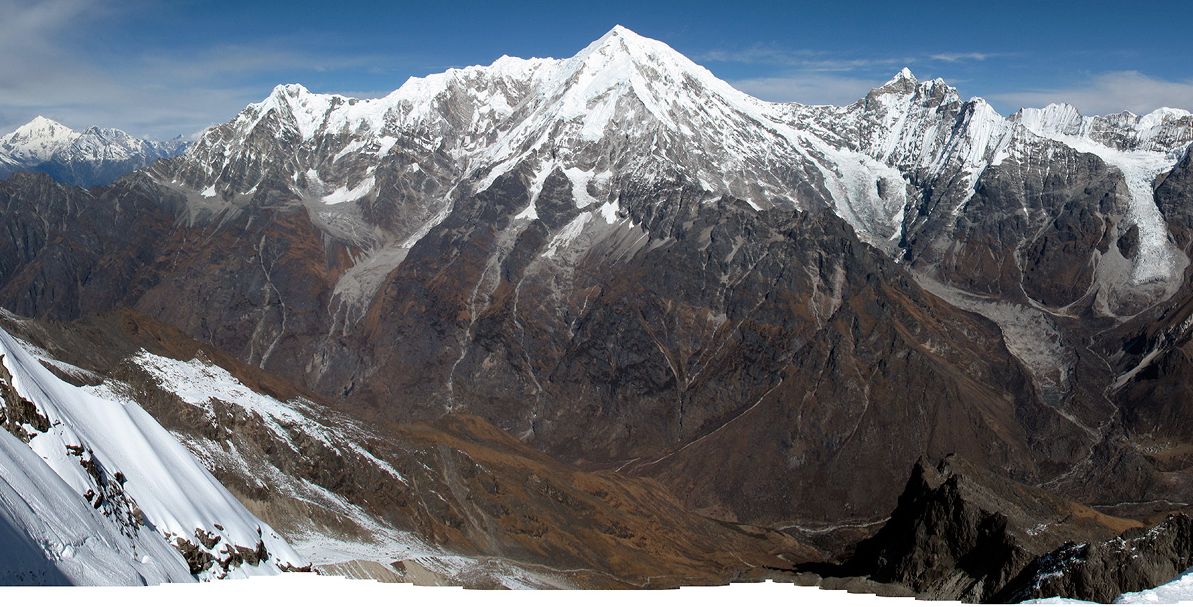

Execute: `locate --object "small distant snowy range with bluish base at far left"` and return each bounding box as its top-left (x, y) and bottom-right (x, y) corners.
top-left (0, 116), bottom-right (187, 186)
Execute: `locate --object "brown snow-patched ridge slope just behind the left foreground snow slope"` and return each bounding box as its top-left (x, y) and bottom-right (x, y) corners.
top-left (4, 312), bottom-right (821, 587)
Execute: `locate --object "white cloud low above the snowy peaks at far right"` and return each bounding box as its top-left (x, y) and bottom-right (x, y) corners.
top-left (990, 72), bottom-right (1193, 114)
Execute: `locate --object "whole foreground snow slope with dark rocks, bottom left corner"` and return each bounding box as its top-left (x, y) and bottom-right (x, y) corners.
top-left (0, 321), bottom-right (304, 584)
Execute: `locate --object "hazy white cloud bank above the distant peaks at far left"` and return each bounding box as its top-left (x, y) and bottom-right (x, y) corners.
top-left (0, 0), bottom-right (396, 137)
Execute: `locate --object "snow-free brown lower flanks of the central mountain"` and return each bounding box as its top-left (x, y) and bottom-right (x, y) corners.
top-left (0, 166), bottom-right (1087, 525)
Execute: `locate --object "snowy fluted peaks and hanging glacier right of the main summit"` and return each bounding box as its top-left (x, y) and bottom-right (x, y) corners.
top-left (789, 69), bottom-right (1193, 284)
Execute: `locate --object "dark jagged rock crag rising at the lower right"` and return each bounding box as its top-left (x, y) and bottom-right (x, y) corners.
top-left (841, 457), bottom-right (1130, 602)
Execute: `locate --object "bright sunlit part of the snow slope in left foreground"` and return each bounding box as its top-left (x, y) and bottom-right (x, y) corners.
top-left (0, 330), bottom-right (305, 583)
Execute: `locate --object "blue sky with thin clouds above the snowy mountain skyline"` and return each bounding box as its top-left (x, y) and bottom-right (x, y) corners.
top-left (0, 0), bottom-right (1193, 137)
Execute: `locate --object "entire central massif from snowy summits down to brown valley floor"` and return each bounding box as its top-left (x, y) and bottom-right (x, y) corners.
top-left (0, 22), bottom-right (1193, 591)
